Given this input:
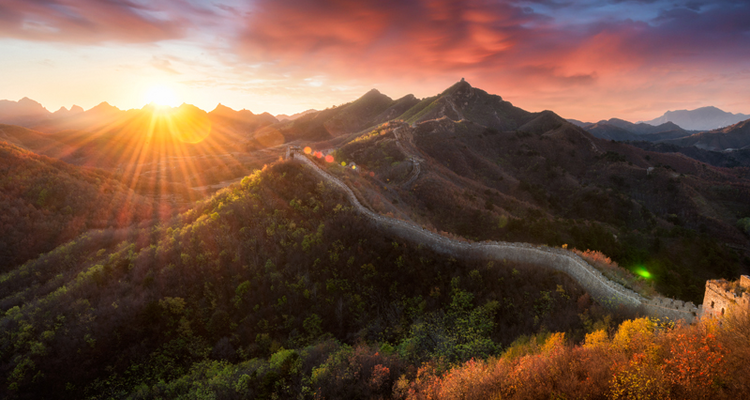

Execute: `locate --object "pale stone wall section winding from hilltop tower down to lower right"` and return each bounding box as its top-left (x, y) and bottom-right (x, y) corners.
top-left (287, 148), bottom-right (701, 322)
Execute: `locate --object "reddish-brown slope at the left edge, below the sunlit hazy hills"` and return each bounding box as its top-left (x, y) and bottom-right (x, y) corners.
top-left (0, 142), bottom-right (156, 272)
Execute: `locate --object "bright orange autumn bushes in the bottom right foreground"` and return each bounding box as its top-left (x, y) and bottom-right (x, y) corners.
top-left (402, 318), bottom-right (750, 399)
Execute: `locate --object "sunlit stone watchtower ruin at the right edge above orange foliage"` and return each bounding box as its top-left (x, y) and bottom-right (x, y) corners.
top-left (703, 275), bottom-right (750, 317)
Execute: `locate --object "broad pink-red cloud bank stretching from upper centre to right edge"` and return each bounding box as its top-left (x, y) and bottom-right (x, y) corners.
top-left (236, 0), bottom-right (750, 94)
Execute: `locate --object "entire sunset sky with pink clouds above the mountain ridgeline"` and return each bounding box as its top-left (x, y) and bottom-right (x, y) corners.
top-left (0, 0), bottom-right (750, 122)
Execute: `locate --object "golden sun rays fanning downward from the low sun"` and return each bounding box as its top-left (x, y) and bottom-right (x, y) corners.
top-left (51, 105), bottom-right (262, 226)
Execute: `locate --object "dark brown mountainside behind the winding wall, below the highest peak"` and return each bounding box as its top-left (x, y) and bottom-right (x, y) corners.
top-left (335, 82), bottom-right (750, 302)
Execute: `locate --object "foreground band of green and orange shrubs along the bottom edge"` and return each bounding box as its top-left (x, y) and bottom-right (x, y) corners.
top-left (106, 316), bottom-right (750, 399)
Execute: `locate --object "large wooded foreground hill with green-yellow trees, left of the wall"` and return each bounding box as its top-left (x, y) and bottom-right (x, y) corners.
top-left (0, 163), bottom-right (600, 398)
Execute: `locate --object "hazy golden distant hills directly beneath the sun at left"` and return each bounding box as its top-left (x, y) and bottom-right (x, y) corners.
top-left (0, 103), bottom-right (281, 202)
